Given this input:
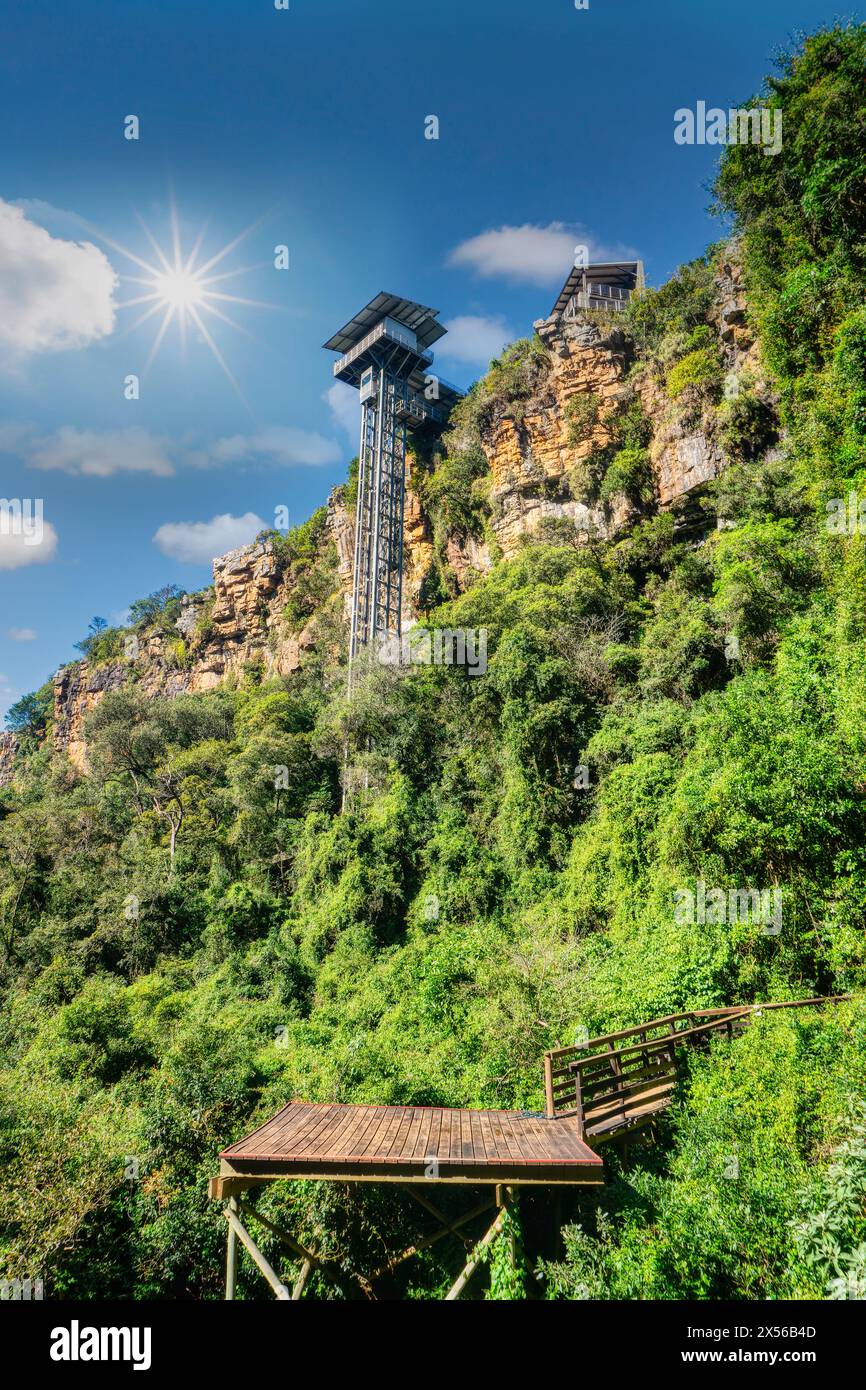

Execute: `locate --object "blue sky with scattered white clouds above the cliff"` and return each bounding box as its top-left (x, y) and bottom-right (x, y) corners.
top-left (0, 0), bottom-right (856, 712)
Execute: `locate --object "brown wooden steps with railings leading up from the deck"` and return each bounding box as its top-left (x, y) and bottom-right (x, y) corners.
top-left (544, 994), bottom-right (849, 1141)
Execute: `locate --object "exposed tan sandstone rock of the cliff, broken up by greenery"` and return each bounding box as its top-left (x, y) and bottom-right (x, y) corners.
top-left (44, 243), bottom-right (762, 785)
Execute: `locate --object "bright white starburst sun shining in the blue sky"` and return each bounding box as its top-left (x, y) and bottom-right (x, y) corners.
top-left (95, 200), bottom-right (279, 400)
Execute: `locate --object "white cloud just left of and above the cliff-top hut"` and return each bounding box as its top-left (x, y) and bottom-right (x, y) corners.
top-left (448, 222), bottom-right (631, 286)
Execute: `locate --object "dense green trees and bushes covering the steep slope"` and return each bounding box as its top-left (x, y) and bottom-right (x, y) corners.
top-left (0, 25), bottom-right (866, 1300)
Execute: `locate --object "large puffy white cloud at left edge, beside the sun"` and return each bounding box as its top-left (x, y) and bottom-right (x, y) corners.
top-left (0, 199), bottom-right (118, 361)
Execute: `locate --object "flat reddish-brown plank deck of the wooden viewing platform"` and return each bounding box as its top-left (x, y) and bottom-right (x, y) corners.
top-left (211, 1101), bottom-right (603, 1197)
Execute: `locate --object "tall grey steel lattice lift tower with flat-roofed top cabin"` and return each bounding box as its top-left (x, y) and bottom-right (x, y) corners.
top-left (325, 292), bottom-right (460, 671)
